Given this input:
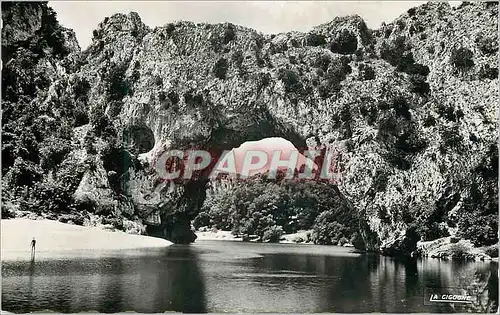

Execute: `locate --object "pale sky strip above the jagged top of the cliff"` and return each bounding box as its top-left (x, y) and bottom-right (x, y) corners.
top-left (49, 0), bottom-right (459, 49)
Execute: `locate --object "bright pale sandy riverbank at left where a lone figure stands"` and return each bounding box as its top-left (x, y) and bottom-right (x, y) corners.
top-left (1, 218), bottom-right (172, 260)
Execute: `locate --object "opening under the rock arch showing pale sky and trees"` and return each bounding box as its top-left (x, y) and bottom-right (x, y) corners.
top-left (188, 137), bottom-right (356, 247)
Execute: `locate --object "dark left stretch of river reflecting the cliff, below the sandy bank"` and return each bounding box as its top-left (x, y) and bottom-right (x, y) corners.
top-left (2, 246), bottom-right (206, 313)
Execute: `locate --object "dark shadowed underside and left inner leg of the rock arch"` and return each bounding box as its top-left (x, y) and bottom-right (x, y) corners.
top-left (141, 110), bottom-right (312, 243)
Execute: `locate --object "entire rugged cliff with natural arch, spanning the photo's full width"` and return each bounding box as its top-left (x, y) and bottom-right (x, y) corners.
top-left (2, 3), bottom-right (498, 255)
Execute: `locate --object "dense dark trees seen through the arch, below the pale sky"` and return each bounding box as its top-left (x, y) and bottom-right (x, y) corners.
top-left (193, 174), bottom-right (359, 244)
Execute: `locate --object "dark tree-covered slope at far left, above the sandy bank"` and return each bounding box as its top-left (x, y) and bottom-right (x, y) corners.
top-left (2, 2), bottom-right (85, 217)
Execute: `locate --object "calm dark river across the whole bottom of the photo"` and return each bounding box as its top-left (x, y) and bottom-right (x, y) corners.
top-left (2, 241), bottom-right (498, 313)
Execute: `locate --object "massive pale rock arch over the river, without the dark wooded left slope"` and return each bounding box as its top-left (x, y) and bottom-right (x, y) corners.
top-left (74, 4), bottom-right (497, 254)
